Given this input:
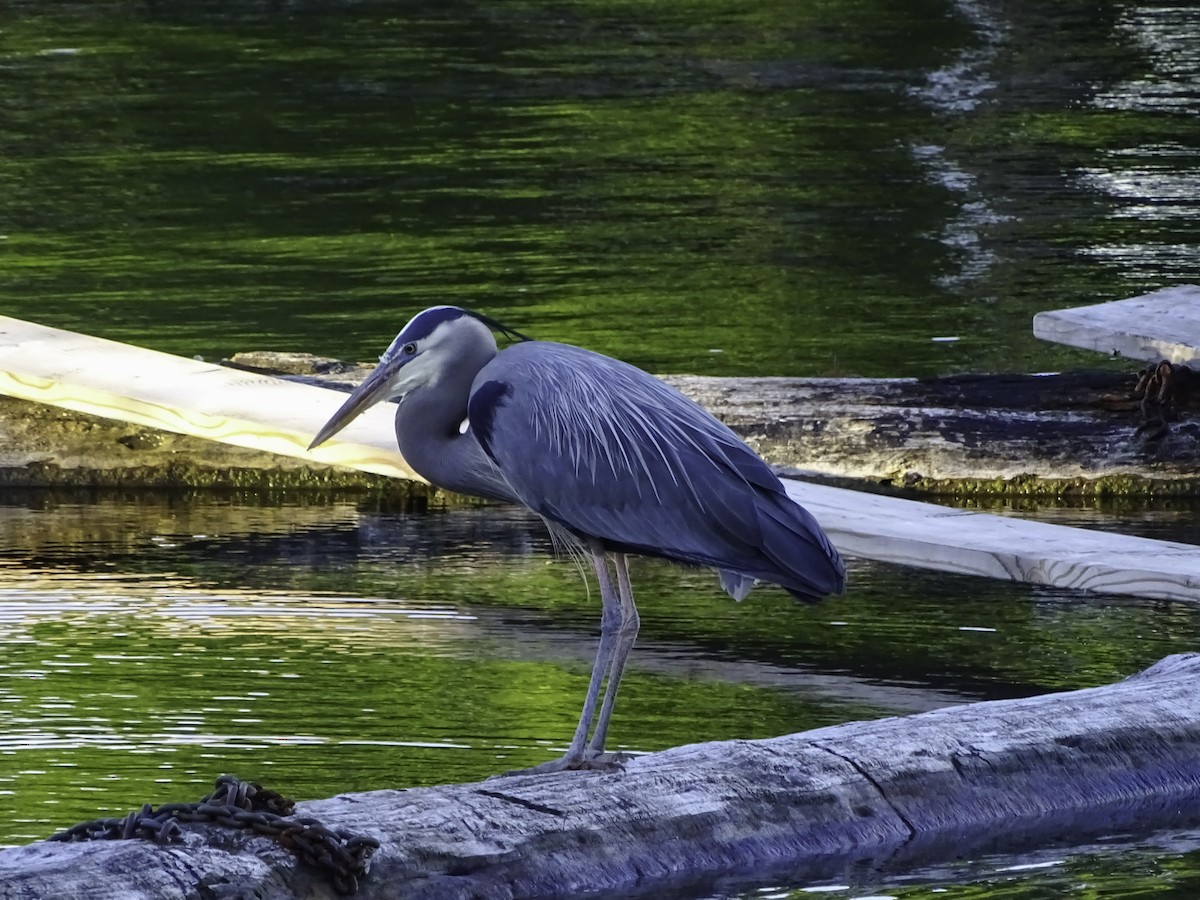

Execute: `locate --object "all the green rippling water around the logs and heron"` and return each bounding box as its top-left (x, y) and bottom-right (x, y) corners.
top-left (0, 0), bottom-right (1200, 899)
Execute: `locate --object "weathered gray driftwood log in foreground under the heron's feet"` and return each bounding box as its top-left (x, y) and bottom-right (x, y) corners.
top-left (0, 654), bottom-right (1200, 900)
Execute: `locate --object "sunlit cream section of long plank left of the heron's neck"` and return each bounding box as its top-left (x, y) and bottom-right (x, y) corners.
top-left (0, 316), bottom-right (419, 487)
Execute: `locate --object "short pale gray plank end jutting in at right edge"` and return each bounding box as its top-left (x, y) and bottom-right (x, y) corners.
top-left (1033, 284), bottom-right (1200, 364)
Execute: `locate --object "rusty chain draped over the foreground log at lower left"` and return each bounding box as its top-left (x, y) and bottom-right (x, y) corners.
top-left (47, 775), bottom-right (379, 894)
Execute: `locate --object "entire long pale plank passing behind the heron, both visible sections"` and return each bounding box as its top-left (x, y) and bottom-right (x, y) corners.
top-left (0, 318), bottom-right (1200, 602)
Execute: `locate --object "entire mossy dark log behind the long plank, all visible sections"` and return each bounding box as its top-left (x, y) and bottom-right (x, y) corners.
top-left (0, 354), bottom-right (1200, 494)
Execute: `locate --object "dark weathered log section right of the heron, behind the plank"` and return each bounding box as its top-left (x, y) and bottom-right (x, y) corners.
top-left (668, 372), bottom-right (1200, 493)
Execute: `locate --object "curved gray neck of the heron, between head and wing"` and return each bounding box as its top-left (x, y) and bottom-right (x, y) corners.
top-left (396, 365), bottom-right (516, 502)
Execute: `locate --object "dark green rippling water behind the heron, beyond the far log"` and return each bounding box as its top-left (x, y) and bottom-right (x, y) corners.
top-left (0, 0), bottom-right (1200, 376)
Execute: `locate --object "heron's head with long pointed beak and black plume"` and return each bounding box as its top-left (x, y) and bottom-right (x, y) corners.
top-left (308, 306), bottom-right (529, 450)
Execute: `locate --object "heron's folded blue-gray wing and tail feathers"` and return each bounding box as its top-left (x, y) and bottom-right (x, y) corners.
top-left (468, 342), bottom-right (844, 596)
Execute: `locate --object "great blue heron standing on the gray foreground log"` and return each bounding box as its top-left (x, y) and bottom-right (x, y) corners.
top-left (310, 306), bottom-right (846, 770)
